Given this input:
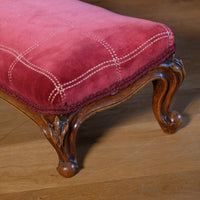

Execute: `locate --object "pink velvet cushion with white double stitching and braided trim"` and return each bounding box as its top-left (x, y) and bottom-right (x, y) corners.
top-left (0, 0), bottom-right (175, 114)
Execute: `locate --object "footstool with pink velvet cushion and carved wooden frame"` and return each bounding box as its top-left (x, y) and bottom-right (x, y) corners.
top-left (0, 0), bottom-right (185, 177)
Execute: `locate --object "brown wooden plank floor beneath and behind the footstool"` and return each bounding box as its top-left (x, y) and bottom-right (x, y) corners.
top-left (0, 0), bottom-right (200, 200)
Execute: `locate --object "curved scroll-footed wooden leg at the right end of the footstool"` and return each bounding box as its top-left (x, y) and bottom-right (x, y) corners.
top-left (153, 57), bottom-right (185, 134)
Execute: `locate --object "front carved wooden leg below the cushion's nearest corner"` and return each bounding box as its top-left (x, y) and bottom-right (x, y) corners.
top-left (42, 113), bottom-right (79, 177)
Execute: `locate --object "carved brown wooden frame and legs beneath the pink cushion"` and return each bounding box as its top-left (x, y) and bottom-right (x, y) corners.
top-left (0, 55), bottom-right (185, 177)
